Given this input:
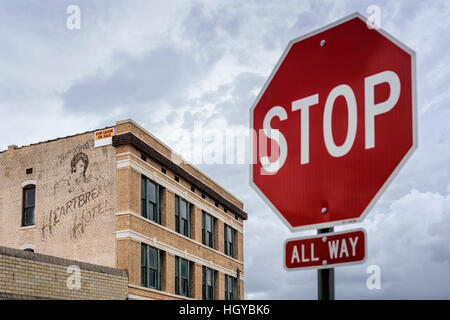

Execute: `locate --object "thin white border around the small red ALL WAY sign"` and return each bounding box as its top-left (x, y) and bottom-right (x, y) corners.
top-left (283, 228), bottom-right (367, 271)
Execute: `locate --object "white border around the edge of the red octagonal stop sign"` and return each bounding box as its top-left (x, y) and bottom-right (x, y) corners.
top-left (249, 12), bottom-right (418, 232)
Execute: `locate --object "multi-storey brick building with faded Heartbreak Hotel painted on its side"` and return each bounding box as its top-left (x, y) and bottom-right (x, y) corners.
top-left (0, 120), bottom-right (247, 299)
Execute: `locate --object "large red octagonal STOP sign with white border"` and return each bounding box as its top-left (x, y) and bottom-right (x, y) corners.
top-left (250, 13), bottom-right (417, 231)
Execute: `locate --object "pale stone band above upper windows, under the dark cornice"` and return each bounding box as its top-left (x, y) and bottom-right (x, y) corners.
top-left (116, 152), bottom-right (244, 233)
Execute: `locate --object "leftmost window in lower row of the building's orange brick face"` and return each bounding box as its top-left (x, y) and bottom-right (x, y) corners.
top-left (141, 243), bottom-right (161, 290)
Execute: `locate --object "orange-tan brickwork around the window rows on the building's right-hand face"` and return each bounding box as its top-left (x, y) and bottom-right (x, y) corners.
top-left (112, 149), bottom-right (244, 299)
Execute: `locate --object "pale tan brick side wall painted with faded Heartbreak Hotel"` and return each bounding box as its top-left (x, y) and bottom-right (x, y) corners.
top-left (0, 132), bottom-right (116, 267)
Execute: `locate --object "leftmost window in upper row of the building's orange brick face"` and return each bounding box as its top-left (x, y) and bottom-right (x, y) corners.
top-left (141, 176), bottom-right (162, 223)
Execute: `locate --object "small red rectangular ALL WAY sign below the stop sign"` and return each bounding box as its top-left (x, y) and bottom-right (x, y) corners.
top-left (283, 229), bottom-right (367, 270)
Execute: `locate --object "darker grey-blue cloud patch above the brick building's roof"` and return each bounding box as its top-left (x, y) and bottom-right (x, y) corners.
top-left (63, 46), bottom-right (214, 112)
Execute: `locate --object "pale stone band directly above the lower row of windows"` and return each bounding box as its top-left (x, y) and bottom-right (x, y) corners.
top-left (114, 229), bottom-right (244, 280)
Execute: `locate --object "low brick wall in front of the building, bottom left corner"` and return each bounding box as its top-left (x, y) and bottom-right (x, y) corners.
top-left (0, 246), bottom-right (128, 300)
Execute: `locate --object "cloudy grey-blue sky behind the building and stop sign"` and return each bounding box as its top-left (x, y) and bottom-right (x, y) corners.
top-left (0, 0), bottom-right (450, 299)
